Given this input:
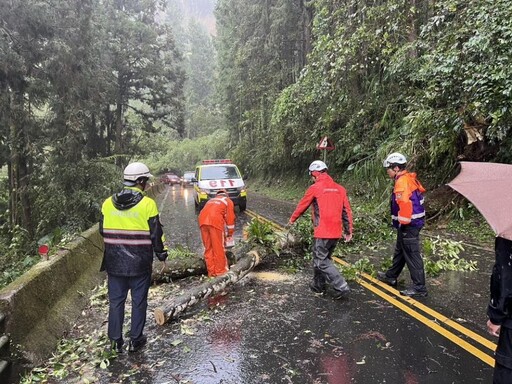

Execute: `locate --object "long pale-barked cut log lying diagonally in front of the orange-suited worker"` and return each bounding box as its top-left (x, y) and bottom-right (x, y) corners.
top-left (154, 249), bottom-right (260, 325)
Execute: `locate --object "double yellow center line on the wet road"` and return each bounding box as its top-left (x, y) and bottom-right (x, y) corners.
top-left (246, 210), bottom-right (496, 366)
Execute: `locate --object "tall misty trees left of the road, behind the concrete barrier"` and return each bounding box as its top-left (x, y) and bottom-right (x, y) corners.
top-left (0, 0), bottom-right (184, 280)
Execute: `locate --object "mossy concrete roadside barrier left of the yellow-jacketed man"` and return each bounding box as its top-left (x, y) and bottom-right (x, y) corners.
top-left (0, 225), bottom-right (105, 364)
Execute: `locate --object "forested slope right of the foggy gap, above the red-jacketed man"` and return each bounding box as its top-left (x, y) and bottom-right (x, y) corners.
top-left (217, 0), bottom-right (512, 193)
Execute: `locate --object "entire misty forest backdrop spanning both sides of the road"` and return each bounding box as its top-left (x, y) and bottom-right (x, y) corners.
top-left (0, 0), bottom-right (512, 281)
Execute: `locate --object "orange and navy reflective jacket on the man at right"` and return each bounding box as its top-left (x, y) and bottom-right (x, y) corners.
top-left (391, 171), bottom-right (425, 228)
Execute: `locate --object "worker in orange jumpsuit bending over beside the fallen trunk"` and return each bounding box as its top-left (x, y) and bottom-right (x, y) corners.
top-left (199, 189), bottom-right (235, 277)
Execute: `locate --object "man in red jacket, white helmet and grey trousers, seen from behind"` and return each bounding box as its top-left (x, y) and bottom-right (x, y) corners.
top-left (288, 160), bottom-right (353, 300)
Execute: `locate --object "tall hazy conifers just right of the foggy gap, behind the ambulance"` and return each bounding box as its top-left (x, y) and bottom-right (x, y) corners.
top-left (216, 0), bottom-right (306, 178)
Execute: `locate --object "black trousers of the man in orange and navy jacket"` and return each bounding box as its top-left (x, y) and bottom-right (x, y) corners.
top-left (386, 225), bottom-right (426, 292)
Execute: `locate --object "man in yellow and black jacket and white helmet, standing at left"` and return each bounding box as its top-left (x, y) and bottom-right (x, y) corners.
top-left (100, 163), bottom-right (167, 353)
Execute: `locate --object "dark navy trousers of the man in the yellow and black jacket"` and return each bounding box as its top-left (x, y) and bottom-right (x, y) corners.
top-left (108, 274), bottom-right (151, 342)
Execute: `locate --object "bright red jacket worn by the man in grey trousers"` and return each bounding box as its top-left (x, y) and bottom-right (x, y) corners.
top-left (290, 173), bottom-right (352, 239)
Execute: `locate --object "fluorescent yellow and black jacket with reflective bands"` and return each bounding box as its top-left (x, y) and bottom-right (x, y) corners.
top-left (100, 187), bottom-right (165, 276)
